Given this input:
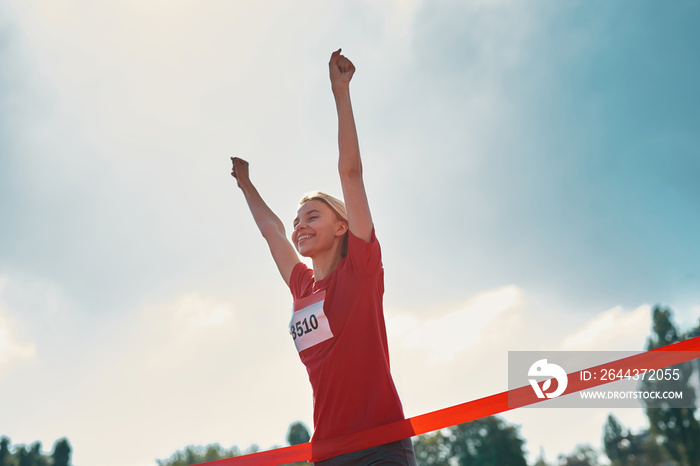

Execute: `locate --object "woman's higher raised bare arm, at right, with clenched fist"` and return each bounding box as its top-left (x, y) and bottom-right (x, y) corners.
top-left (328, 49), bottom-right (373, 241)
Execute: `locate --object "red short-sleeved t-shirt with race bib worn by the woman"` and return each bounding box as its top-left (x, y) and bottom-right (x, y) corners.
top-left (289, 231), bottom-right (404, 448)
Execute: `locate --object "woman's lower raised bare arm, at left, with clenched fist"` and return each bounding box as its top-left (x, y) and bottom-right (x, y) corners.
top-left (231, 157), bottom-right (299, 286)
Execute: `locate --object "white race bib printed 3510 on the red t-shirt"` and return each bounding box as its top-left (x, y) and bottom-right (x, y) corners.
top-left (289, 290), bottom-right (333, 352)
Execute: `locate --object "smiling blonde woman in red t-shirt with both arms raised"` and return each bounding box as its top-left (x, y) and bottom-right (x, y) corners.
top-left (231, 49), bottom-right (415, 465)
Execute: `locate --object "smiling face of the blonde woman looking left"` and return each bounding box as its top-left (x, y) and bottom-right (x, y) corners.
top-left (292, 199), bottom-right (347, 258)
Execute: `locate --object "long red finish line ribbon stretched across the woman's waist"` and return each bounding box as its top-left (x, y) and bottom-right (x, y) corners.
top-left (201, 337), bottom-right (700, 466)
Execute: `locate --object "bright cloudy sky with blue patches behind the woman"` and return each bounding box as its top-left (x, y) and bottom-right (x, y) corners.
top-left (0, 0), bottom-right (700, 466)
